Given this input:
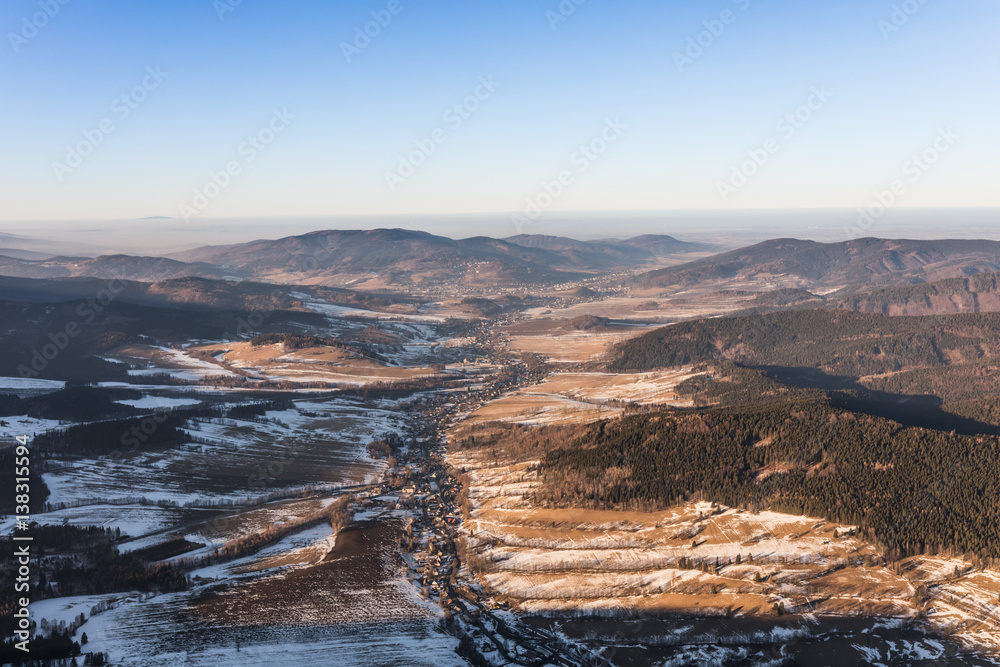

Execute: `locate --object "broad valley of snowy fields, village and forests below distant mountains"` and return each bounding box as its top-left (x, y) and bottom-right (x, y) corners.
top-left (0, 231), bottom-right (1000, 666)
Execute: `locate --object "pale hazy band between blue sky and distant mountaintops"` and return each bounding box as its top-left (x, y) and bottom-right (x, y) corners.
top-left (0, 207), bottom-right (1000, 256)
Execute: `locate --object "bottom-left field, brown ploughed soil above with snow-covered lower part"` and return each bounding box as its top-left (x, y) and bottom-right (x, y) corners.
top-left (75, 517), bottom-right (465, 667)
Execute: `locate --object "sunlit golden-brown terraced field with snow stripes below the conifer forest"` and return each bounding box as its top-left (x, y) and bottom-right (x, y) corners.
top-left (449, 450), bottom-right (1000, 648)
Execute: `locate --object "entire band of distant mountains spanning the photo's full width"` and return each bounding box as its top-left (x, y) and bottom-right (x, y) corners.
top-left (9, 229), bottom-right (1000, 300)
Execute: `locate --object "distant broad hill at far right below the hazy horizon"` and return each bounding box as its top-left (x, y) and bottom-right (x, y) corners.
top-left (636, 238), bottom-right (1000, 289)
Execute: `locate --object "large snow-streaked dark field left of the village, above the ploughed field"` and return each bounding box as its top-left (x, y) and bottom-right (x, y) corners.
top-left (36, 399), bottom-right (404, 537)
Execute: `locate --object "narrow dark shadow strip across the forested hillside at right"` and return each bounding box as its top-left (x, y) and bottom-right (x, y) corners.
top-left (757, 366), bottom-right (1000, 435)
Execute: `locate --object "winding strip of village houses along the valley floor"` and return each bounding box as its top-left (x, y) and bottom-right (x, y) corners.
top-left (348, 316), bottom-right (611, 667)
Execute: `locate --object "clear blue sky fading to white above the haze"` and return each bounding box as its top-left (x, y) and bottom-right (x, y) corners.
top-left (0, 0), bottom-right (1000, 224)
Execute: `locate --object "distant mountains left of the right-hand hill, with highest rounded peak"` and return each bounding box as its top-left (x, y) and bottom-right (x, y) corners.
top-left (0, 229), bottom-right (707, 287)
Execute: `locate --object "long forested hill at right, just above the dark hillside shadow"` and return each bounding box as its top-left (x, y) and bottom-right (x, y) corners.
top-left (608, 310), bottom-right (1000, 377)
